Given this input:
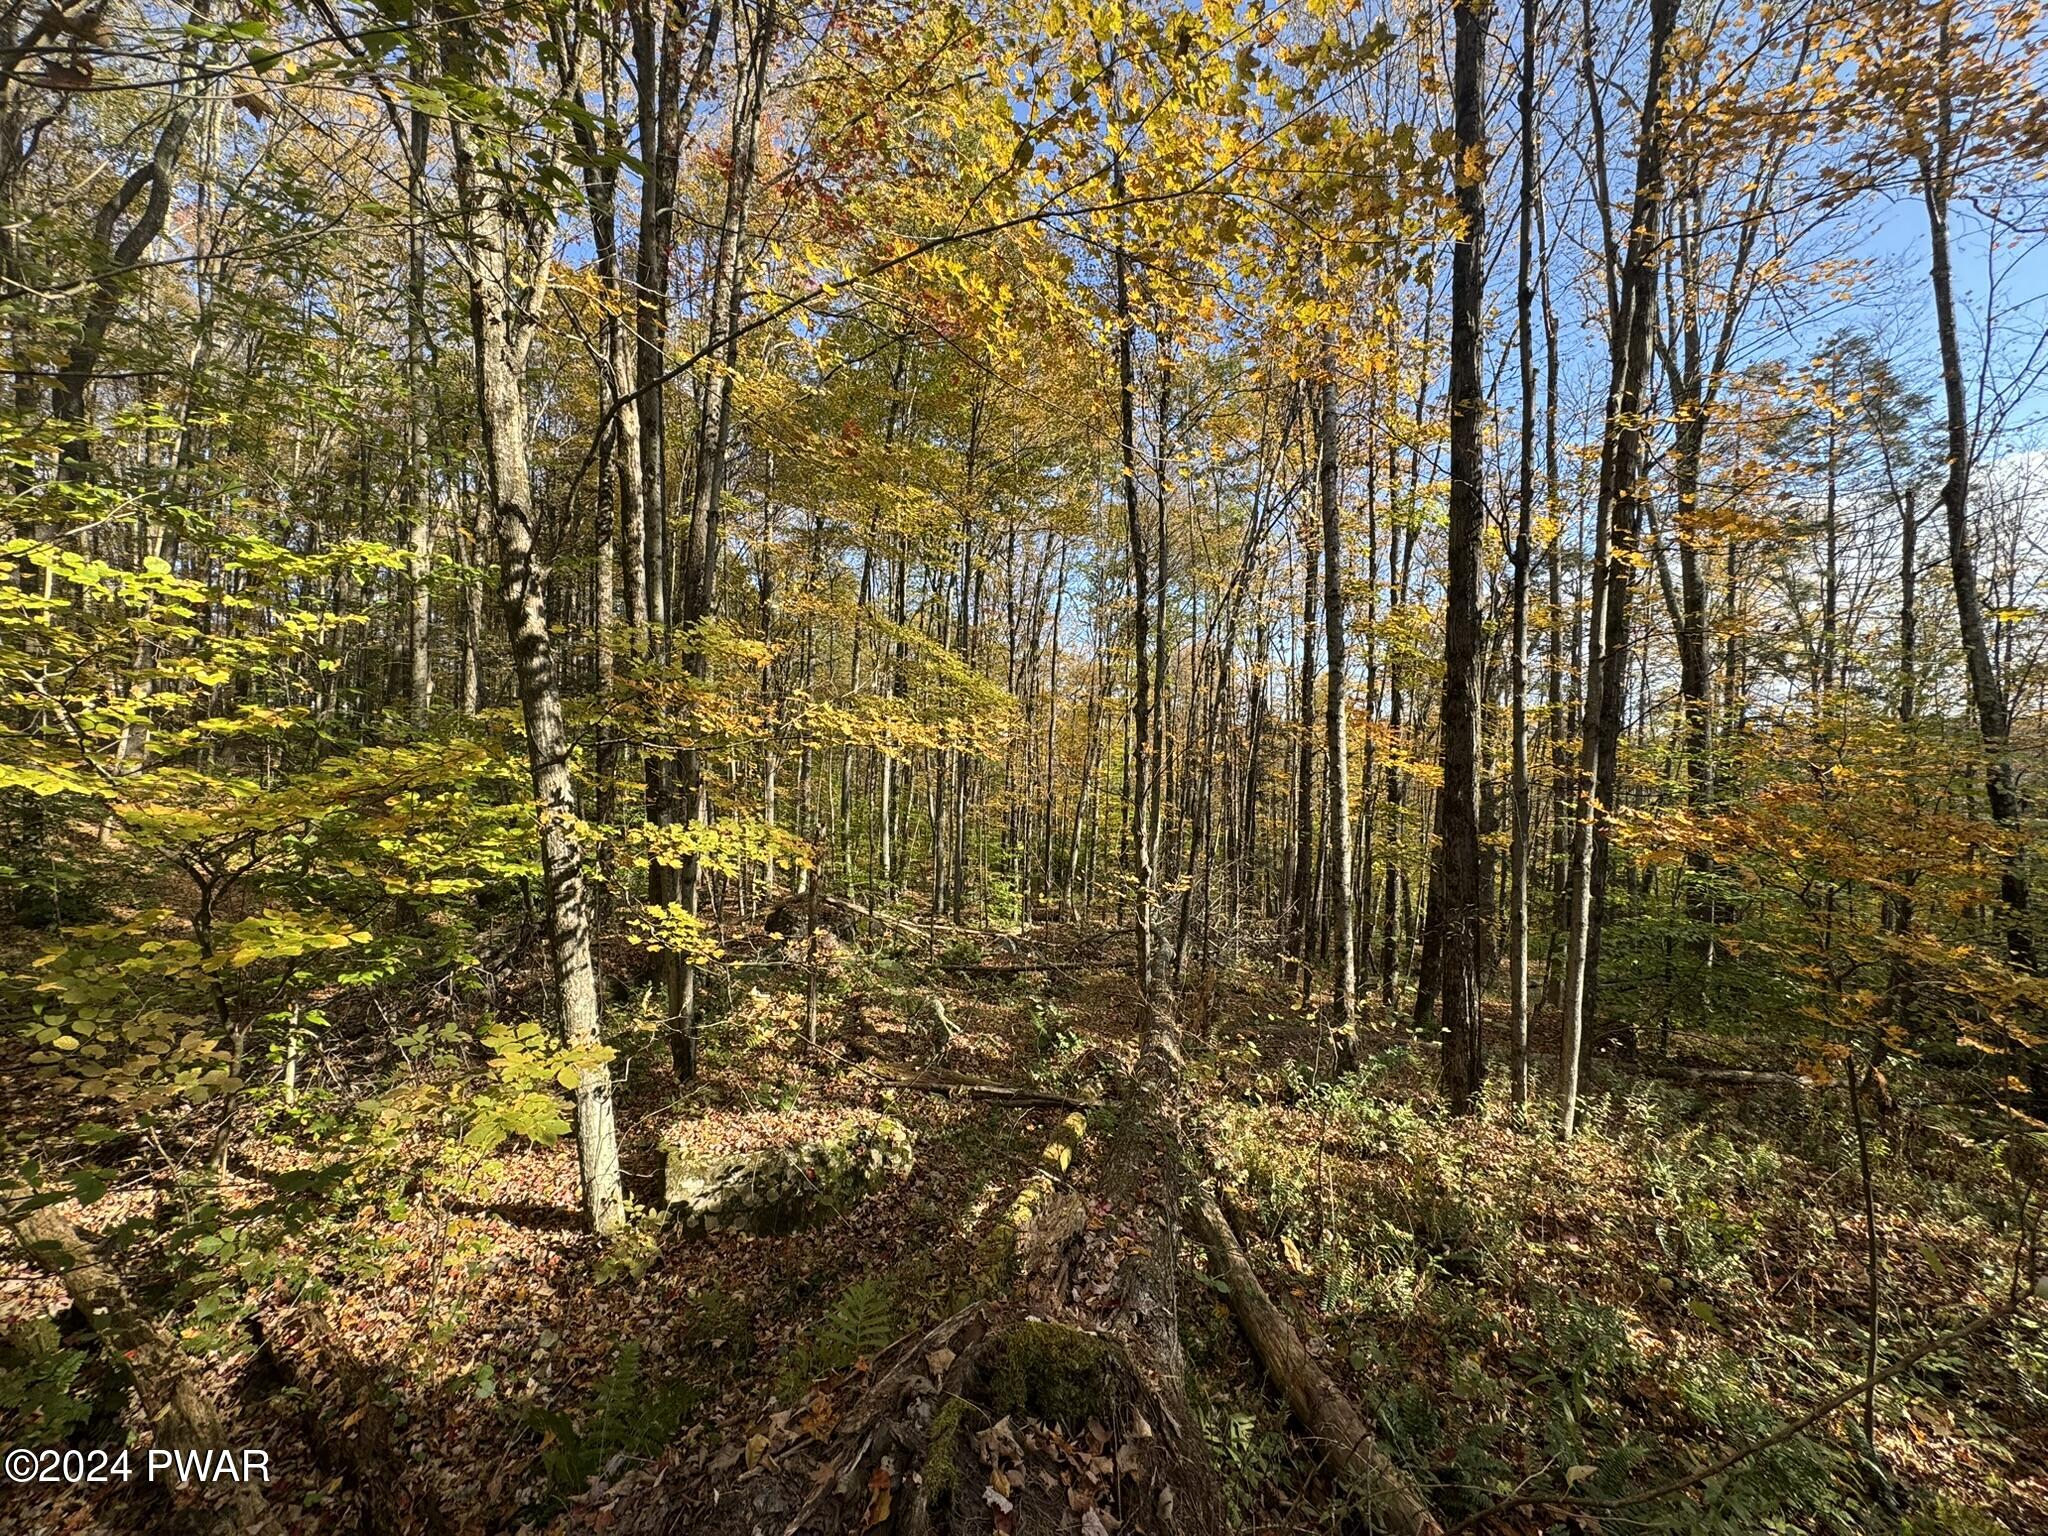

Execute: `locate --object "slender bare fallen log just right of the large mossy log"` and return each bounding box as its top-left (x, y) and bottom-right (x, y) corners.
top-left (1190, 1188), bottom-right (1442, 1536)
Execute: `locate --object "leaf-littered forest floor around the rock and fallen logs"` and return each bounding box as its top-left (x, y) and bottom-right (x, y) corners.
top-left (0, 930), bottom-right (2048, 1536)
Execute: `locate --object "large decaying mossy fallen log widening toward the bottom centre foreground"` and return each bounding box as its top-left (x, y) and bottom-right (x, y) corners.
top-left (753, 1001), bottom-right (1229, 1536)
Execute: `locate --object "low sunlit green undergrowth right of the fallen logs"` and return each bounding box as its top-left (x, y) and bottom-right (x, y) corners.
top-left (1194, 1047), bottom-right (2048, 1536)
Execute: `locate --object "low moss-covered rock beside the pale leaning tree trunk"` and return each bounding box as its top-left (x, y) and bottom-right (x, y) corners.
top-left (666, 1114), bottom-right (913, 1237)
